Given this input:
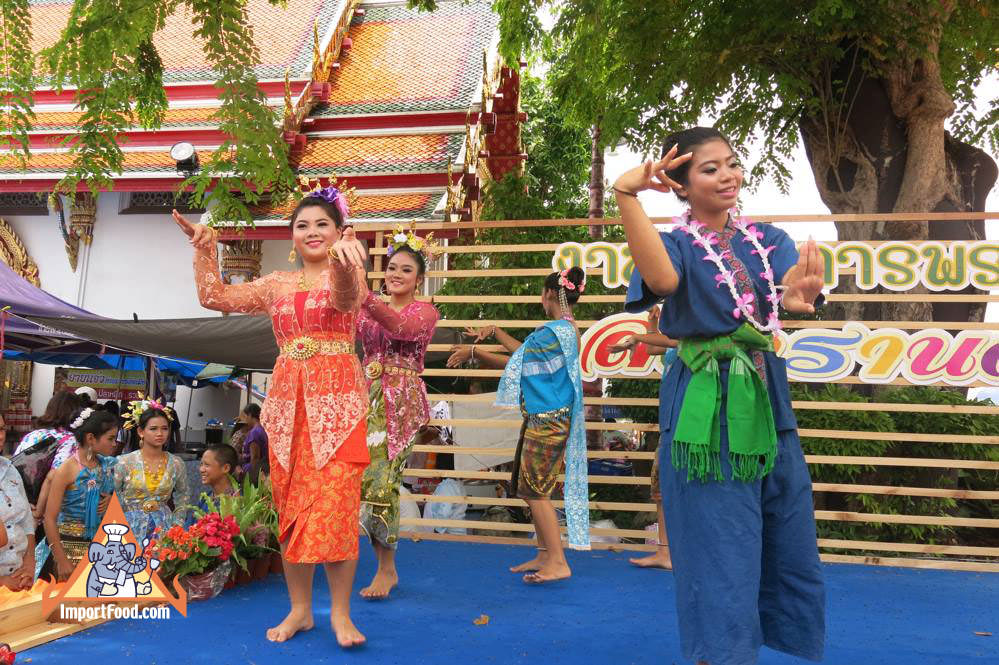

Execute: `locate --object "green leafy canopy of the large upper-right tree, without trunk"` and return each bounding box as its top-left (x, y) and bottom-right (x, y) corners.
top-left (410, 0), bottom-right (999, 183)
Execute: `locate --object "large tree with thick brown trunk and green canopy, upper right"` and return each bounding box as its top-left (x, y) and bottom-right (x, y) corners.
top-left (414, 0), bottom-right (999, 320)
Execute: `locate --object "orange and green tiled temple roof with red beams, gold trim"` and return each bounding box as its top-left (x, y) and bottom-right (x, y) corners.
top-left (0, 0), bottom-right (519, 227)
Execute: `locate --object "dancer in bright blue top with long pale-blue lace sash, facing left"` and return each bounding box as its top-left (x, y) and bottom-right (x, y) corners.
top-left (447, 267), bottom-right (590, 584)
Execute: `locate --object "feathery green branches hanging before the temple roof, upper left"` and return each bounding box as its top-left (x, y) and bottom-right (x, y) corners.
top-left (0, 0), bottom-right (295, 221)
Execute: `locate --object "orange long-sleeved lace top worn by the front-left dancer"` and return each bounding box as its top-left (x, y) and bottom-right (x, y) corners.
top-left (194, 241), bottom-right (368, 469)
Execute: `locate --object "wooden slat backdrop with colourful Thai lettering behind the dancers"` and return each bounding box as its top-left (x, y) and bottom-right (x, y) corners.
top-left (356, 213), bottom-right (999, 571)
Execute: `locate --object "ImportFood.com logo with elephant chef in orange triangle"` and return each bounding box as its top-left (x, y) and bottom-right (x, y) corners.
top-left (42, 495), bottom-right (187, 621)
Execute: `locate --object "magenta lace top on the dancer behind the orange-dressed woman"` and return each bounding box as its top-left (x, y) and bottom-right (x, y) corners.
top-left (357, 292), bottom-right (440, 459)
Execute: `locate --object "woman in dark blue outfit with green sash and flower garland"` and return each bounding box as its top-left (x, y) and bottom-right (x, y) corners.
top-left (614, 127), bottom-right (825, 665)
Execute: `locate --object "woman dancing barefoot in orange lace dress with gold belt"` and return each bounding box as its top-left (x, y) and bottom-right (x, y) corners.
top-left (174, 187), bottom-right (369, 647)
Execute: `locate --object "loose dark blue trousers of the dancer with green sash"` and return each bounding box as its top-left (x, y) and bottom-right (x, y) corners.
top-left (659, 418), bottom-right (825, 665)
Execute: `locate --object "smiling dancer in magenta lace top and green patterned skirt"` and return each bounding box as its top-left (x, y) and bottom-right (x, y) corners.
top-left (357, 228), bottom-right (440, 598)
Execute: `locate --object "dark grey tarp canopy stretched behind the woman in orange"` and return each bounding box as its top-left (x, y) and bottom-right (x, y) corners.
top-left (29, 316), bottom-right (457, 372)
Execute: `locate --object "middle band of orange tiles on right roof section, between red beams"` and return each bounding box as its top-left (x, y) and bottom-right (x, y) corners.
top-left (298, 134), bottom-right (464, 176)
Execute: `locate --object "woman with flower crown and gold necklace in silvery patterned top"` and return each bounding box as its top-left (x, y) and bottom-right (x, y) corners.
top-left (114, 399), bottom-right (190, 544)
